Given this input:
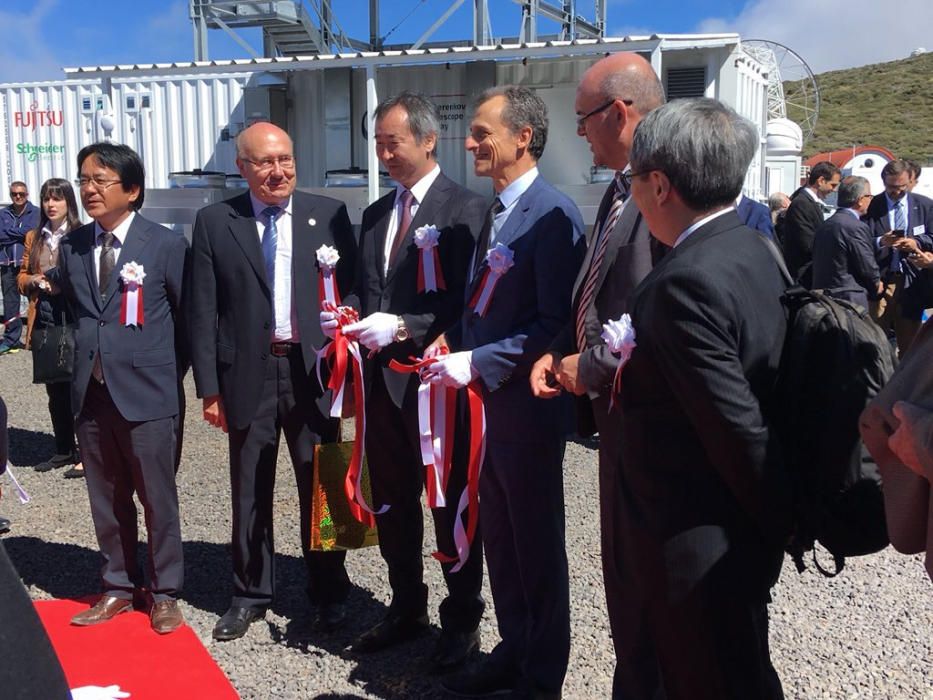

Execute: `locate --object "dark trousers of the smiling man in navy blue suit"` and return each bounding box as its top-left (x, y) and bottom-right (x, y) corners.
top-left (480, 432), bottom-right (570, 692)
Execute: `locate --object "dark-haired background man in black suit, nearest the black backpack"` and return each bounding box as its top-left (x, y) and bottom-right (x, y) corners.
top-left (784, 160), bottom-right (842, 282)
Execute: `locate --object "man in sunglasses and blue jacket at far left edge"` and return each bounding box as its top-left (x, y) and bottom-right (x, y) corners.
top-left (0, 180), bottom-right (39, 355)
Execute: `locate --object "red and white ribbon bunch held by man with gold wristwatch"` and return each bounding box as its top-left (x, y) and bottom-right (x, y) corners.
top-left (316, 301), bottom-right (389, 527)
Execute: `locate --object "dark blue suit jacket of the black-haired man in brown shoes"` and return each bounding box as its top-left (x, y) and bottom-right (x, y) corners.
top-left (47, 214), bottom-right (188, 421)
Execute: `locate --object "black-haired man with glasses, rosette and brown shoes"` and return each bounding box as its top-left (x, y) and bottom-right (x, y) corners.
top-left (52, 143), bottom-right (188, 633)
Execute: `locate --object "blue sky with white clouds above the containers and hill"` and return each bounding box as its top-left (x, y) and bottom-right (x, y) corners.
top-left (0, 0), bottom-right (933, 83)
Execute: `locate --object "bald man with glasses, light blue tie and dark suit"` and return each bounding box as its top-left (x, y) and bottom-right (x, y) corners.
top-left (188, 122), bottom-right (356, 640)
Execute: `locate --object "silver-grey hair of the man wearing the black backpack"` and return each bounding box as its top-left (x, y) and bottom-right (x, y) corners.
top-left (631, 97), bottom-right (759, 211)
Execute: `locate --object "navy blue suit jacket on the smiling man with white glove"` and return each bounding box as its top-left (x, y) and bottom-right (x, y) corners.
top-left (447, 175), bottom-right (585, 440)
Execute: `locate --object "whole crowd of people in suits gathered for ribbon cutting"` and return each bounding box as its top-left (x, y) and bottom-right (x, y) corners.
top-left (0, 53), bottom-right (933, 699)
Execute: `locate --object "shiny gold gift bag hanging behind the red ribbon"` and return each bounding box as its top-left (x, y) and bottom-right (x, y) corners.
top-left (309, 441), bottom-right (379, 552)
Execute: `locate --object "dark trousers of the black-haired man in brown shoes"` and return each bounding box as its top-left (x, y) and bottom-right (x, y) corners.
top-left (76, 379), bottom-right (184, 602)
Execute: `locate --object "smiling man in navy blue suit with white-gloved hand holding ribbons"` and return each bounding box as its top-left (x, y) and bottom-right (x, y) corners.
top-left (427, 86), bottom-right (584, 698)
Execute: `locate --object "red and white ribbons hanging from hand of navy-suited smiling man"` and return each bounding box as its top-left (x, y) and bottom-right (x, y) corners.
top-left (389, 358), bottom-right (486, 573)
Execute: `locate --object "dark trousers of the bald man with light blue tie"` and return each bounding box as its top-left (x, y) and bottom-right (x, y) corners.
top-left (229, 345), bottom-right (350, 610)
